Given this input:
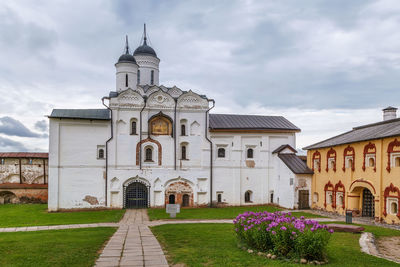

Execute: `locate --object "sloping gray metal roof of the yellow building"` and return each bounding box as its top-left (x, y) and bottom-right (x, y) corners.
top-left (303, 118), bottom-right (400, 150)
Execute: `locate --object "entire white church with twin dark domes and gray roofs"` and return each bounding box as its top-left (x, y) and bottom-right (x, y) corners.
top-left (48, 26), bottom-right (312, 211)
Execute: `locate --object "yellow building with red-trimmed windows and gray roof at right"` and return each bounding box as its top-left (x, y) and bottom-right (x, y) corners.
top-left (304, 107), bottom-right (400, 223)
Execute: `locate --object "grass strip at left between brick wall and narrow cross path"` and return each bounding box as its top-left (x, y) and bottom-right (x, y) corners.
top-left (0, 204), bottom-right (125, 227)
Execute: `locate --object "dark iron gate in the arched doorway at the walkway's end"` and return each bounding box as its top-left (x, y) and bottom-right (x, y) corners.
top-left (125, 182), bottom-right (149, 209)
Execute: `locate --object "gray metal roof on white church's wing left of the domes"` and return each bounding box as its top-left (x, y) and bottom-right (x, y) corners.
top-left (49, 109), bottom-right (110, 120)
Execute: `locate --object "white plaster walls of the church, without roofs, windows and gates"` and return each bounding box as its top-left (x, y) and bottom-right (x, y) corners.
top-left (48, 31), bottom-right (311, 211)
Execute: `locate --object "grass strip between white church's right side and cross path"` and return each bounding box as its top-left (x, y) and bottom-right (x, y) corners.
top-left (147, 205), bottom-right (322, 221)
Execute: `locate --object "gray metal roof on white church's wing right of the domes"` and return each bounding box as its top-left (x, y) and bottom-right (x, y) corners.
top-left (210, 114), bottom-right (300, 131)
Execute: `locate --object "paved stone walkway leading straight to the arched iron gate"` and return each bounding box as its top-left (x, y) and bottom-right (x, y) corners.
top-left (95, 209), bottom-right (168, 267)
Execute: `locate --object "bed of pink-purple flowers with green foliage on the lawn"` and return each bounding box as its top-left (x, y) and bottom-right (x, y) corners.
top-left (233, 211), bottom-right (333, 261)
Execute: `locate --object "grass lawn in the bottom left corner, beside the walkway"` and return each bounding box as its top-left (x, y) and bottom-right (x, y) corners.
top-left (0, 227), bottom-right (116, 267)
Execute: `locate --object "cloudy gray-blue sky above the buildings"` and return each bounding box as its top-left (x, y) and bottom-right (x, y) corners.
top-left (0, 0), bottom-right (400, 151)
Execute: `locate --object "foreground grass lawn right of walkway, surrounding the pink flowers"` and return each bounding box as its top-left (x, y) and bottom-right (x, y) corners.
top-left (151, 224), bottom-right (398, 267)
